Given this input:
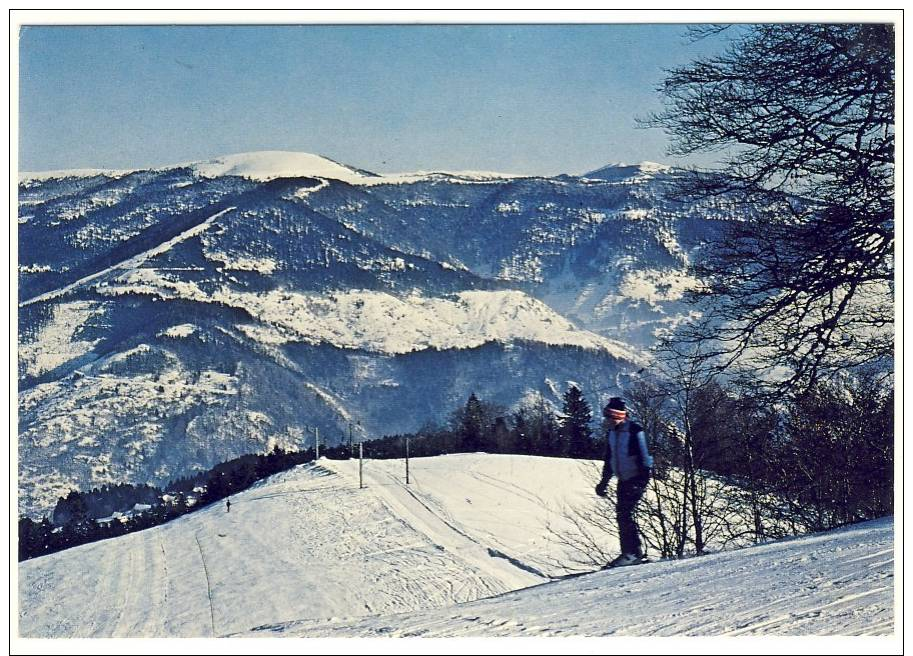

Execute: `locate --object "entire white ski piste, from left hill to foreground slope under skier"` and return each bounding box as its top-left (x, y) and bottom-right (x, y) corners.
top-left (18, 454), bottom-right (895, 638)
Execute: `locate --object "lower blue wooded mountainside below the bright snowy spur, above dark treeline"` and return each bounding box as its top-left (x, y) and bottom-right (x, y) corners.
top-left (19, 288), bottom-right (627, 516)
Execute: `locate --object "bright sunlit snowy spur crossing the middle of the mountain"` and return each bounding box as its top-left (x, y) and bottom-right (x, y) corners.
top-left (99, 276), bottom-right (638, 362)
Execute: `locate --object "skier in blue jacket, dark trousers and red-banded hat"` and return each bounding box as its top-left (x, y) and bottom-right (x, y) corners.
top-left (596, 397), bottom-right (653, 567)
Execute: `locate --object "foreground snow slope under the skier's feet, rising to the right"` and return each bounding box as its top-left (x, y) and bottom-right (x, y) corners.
top-left (260, 519), bottom-right (894, 637)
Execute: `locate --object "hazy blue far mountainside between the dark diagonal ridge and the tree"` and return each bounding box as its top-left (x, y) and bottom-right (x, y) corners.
top-left (307, 166), bottom-right (732, 346)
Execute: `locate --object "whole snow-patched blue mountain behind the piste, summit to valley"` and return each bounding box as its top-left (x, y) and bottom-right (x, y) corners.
top-left (18, 152), bottom-right (734, 514)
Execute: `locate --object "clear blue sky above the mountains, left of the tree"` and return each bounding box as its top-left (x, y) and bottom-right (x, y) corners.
top-left (19, 25), bottom-right (724, 174)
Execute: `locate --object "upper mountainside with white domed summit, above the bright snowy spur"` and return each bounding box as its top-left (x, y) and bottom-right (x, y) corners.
top-left (19, 153), bottom-right (728, 356)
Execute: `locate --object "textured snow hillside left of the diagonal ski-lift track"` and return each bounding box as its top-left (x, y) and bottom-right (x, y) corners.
top-left (20, 461), bottom-right (542, 637)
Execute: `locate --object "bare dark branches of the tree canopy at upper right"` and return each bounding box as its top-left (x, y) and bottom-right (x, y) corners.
top-left (647, 24), bottom-right (894, 389)
